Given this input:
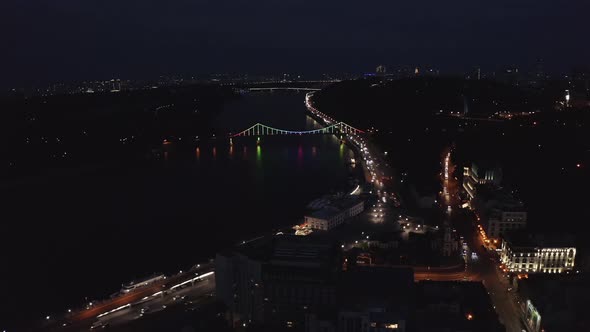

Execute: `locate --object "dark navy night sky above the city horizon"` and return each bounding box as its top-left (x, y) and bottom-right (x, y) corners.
top-left (0, 0), bottom-right (590, 86)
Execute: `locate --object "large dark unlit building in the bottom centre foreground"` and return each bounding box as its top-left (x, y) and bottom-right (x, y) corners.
top-left (215, 235), bottom-right (341, 330)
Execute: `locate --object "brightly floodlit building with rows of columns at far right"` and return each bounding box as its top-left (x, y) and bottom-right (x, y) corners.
top-left (500, 230), bottom-right (576, 274)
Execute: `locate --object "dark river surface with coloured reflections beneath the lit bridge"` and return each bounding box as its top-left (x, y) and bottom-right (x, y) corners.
top-left (0, 94), bottom-right (352, 330)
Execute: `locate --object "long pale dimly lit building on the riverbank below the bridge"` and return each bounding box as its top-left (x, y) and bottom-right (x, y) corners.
top-left (305, 196), bottom-right (365, 231)
